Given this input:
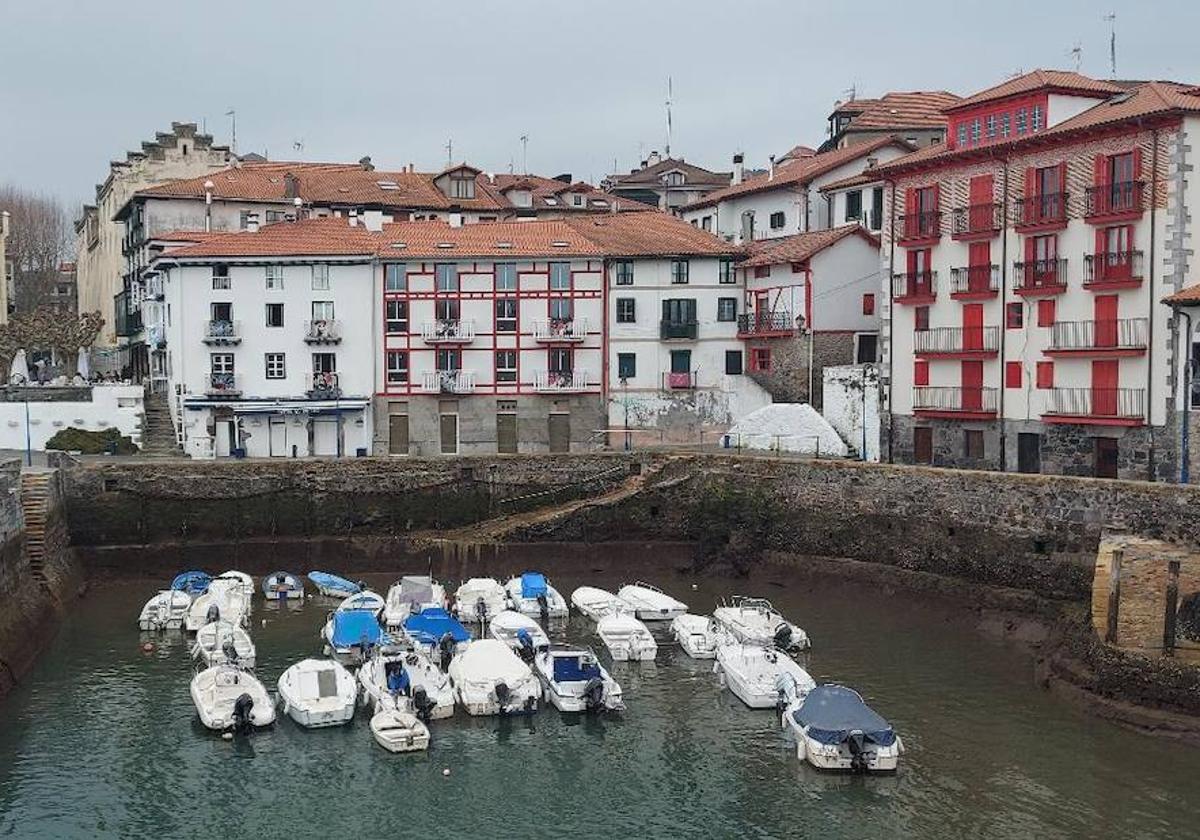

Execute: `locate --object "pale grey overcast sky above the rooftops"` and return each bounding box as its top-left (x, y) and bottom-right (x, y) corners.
top-left (0, 0), bottom-right (1200, 210)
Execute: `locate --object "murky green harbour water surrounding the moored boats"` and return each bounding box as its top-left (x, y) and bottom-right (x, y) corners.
top-left (0, 550), bottom-right (1200, 839)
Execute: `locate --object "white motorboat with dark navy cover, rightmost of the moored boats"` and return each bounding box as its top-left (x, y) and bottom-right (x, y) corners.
top-left (782, 685), bottom-right (904, 773)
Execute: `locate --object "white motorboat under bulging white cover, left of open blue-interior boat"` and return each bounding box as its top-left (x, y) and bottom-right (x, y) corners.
top-left (450, 638), bottom-right (541, 715)
